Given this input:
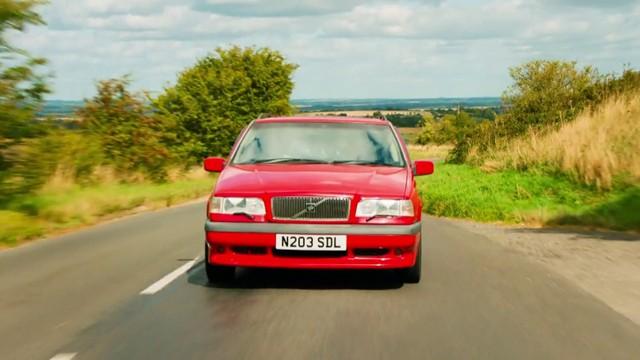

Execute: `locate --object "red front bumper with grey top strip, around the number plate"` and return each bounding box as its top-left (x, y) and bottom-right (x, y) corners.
top-left (205, 221), bottom-right (422, 269)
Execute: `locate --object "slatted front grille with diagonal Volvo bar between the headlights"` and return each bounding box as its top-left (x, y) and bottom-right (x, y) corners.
top-left (271, 196), bottom-right (351, 220)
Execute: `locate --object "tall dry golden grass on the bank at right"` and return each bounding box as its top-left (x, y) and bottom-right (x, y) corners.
top-left (483, 93), bottom-right (640, 189)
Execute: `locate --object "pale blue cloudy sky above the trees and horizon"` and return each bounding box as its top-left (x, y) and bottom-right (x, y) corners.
top-left (12, 0), bottom-right (640, 100)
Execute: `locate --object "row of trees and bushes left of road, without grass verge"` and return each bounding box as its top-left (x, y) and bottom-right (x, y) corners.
top-left (0, 0), bottom-right (297, 205)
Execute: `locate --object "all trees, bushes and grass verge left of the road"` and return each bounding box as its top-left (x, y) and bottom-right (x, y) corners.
top-left (0, 0), bottom-right (297, 247)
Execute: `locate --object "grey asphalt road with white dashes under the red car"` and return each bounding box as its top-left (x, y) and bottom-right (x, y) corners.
top-left (0, 204), bottom-right (640, 359)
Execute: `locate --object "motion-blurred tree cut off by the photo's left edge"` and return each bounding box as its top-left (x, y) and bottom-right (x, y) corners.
top-left (0, 0), bottom-right (48, 198)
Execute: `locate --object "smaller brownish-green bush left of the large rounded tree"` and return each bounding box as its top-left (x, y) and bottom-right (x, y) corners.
top-left (78, 78), bottom-right (173, 181)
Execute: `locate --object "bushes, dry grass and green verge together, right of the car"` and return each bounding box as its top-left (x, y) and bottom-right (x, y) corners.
top-left (418, 61), bottom-right (640, 231)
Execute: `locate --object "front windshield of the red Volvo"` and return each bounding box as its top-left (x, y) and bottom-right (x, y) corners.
top-left (231, 121), bottom-right (405, 167)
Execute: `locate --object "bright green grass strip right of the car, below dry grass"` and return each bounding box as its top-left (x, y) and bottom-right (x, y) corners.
top-left (418, 164), bottom-right (640, 230)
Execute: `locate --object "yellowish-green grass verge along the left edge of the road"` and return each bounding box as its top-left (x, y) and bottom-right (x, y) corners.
top-left (0, 176), bottom-right (215, 247)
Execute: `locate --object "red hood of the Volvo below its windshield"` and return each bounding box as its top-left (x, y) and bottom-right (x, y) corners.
top-left (215, 164), bottom-right (410, 197)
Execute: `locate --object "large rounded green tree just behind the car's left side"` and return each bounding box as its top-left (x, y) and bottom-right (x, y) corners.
top-left (155, 46), bottom-right (297, 162)
